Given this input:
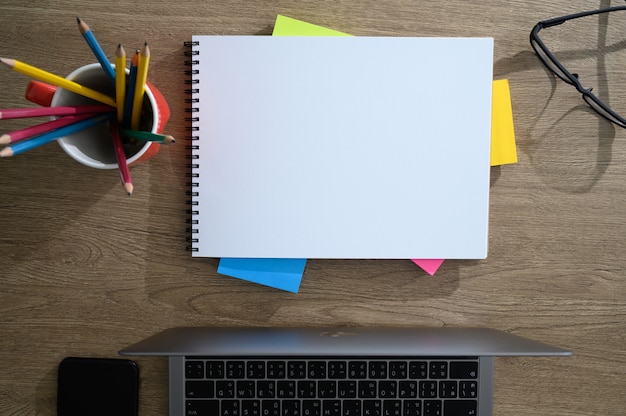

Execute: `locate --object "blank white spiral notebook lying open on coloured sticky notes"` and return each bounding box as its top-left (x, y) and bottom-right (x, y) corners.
top-left (184, 36), bottom-right (493, 259)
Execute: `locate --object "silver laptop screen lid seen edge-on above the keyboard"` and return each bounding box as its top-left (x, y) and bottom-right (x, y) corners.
top-left (119, 327), bottom-right (571, 357)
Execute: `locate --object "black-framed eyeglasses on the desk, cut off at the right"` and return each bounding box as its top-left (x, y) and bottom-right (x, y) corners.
top-left (530, 6), bottom-right (626, 128)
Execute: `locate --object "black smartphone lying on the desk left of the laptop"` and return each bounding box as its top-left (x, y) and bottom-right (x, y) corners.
top-left (57, 357), bottom-right (139, 416)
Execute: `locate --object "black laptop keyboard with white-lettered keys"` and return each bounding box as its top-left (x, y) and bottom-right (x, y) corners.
top-left (185, 357), bottom-right (478, 416)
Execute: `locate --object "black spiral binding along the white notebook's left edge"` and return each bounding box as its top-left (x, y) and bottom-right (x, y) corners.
top-left (185, 41), bottom-right (200, 251)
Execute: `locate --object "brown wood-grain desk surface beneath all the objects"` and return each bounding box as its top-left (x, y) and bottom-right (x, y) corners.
top-left (0, 0), bottom-right (626, 415)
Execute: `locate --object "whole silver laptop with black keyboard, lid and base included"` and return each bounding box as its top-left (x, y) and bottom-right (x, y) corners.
top-left (119, 327), bottom-right (571, 416)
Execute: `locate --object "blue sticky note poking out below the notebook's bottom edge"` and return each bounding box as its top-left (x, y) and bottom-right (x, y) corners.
top-left (217, 258), bottom-right (306, 293)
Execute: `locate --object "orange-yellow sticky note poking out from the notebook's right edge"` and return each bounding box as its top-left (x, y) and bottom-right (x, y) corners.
top-left (491, 79), bottom-right (517, 166)
